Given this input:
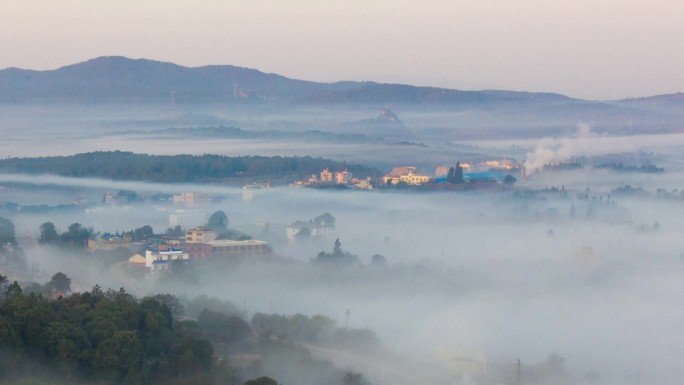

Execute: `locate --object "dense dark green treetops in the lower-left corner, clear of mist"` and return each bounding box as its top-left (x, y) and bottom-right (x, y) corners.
top-left (0, 277), bottom-right (217, 384)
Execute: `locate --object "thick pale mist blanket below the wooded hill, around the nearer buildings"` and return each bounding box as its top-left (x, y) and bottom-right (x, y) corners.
top-left (6, 163), bottom-right (684, 383)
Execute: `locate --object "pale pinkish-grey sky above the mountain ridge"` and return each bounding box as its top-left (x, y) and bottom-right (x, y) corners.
top-left (0, 0), bottom-right (684, 99)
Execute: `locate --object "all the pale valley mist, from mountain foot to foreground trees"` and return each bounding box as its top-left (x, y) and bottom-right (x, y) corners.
top-left (0, 106), bottom-right (684, 384)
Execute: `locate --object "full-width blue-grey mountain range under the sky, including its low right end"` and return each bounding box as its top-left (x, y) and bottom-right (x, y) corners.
top-left (0, 56), bottom-right (684, 116)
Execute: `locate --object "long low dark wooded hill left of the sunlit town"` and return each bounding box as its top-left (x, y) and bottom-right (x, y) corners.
top-left (0, 151), bottom-right (380, 183)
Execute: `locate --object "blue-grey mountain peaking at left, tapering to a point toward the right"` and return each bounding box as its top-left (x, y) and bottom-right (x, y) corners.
top-left (0, 56), bottom-right (574, 104)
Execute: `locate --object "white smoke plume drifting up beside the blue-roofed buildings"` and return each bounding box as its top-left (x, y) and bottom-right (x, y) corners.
top-left (525, 123), bottom-right (598, 175)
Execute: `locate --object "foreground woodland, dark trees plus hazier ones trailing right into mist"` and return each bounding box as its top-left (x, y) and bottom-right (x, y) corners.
top-left (0, 276), bottom-right (377, 385)
